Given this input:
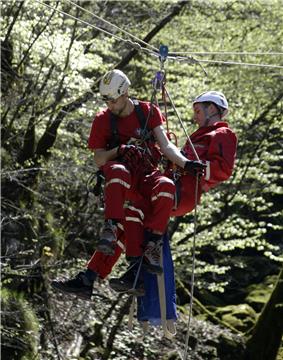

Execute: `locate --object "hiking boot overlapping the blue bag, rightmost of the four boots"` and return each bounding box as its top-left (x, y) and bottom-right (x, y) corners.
top-left (143, 240), bottom-right (163, 275)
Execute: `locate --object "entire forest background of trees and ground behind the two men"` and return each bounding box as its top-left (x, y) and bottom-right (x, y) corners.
top-left (1, 0), bottom-right (283, 360)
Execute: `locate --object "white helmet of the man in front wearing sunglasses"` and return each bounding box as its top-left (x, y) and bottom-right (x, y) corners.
top-left (99, 69), bottom-right (131, 101)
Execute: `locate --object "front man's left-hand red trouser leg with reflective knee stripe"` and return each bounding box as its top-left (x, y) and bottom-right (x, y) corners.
top-left (103, 161), bottom-right (131, 219)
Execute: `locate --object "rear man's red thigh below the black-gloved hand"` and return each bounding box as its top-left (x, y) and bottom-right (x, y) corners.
top-left (170, 175), bottom-right (201, 216)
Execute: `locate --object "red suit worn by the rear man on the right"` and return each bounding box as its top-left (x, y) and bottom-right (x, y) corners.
top-left (88, 122), bottom-right (237, 278)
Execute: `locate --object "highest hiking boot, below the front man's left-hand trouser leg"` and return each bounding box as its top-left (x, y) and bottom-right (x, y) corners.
top-left (96, 220), bottom-right (117, 255)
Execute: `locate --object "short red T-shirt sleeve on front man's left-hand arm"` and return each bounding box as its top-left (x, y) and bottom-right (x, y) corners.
top-left (88, 112), bottom-right (110, 150)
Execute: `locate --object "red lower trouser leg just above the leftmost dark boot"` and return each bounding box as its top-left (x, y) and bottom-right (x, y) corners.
top-left (87, 231), bottom-right (124, 279)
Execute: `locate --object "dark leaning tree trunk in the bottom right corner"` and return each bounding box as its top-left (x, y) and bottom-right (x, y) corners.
top-left (245, 268), bottom-right (283, 360)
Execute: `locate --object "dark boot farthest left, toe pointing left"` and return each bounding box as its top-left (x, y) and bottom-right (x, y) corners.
top-left (51, 272), bottom-right (93, 300)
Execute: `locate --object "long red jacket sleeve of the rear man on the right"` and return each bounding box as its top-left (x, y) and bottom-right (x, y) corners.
top-left (203, 128), bottom-right (237, 187)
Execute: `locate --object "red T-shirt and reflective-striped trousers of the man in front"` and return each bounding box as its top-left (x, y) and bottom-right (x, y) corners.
top-left (89, 101), bottom-right (175, 256)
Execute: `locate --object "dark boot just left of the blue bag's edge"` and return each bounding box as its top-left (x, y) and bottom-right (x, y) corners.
top-left (109, 262), bottom-right (145, 296)
